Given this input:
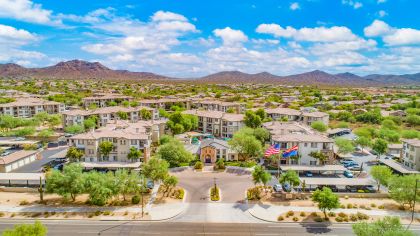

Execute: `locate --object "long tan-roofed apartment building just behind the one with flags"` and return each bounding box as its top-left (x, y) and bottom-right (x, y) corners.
top-left (265, 107), bottom-right (329, 126)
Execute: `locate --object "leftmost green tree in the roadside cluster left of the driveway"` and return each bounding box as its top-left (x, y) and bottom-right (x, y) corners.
top-left (46, 163), bottom-right (84, 201)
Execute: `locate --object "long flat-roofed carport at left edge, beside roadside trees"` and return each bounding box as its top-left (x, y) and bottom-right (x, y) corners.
top-left (0, 173), bottom-right (45, 187)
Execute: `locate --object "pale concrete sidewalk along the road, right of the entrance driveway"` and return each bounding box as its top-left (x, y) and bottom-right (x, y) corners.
top-left (248, 204), bottom-right (420, 222)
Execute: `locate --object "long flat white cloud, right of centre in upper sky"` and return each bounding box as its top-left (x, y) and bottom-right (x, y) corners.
top-left (256, 24), bottom-right (357, 42)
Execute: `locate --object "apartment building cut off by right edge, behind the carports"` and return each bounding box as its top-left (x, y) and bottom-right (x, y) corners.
top-left (402, 139), bottom-right (420, 171)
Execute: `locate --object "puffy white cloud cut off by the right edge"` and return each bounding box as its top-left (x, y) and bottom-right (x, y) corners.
top-left (364, 20), bottom-right (420, 46)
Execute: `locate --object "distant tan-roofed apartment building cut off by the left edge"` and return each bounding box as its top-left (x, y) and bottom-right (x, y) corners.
top-left (0, 97), bottom-right (66, 118)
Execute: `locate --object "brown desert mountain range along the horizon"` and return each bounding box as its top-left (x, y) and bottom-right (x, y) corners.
top-left (0, 60), bottom-right (420, 87)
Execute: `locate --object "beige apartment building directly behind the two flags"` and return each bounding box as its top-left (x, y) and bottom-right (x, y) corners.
top-left (263, 121), bottom-right (334, 165)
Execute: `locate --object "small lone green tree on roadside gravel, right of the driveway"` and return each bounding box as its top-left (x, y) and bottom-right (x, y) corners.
top-left (312, 187), bottom-right (340, 219)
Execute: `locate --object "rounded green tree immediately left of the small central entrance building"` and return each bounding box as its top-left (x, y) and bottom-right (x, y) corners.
top-left (156, 139), bottom-right (194, 167)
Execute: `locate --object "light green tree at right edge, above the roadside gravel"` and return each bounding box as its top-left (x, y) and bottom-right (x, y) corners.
top-left (388, 175), bottom-right (420, 208)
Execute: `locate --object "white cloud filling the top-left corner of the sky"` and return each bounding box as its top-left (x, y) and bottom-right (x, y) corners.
top-left (0, 0), bottom-right (61, 25)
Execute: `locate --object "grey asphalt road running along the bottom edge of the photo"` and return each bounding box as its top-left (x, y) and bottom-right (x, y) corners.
top-left (0, 220), bottom-right (364, 236)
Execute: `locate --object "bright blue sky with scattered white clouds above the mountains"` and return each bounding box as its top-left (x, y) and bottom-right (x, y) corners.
top-left (0, 0), bottom-right (420, 77)
